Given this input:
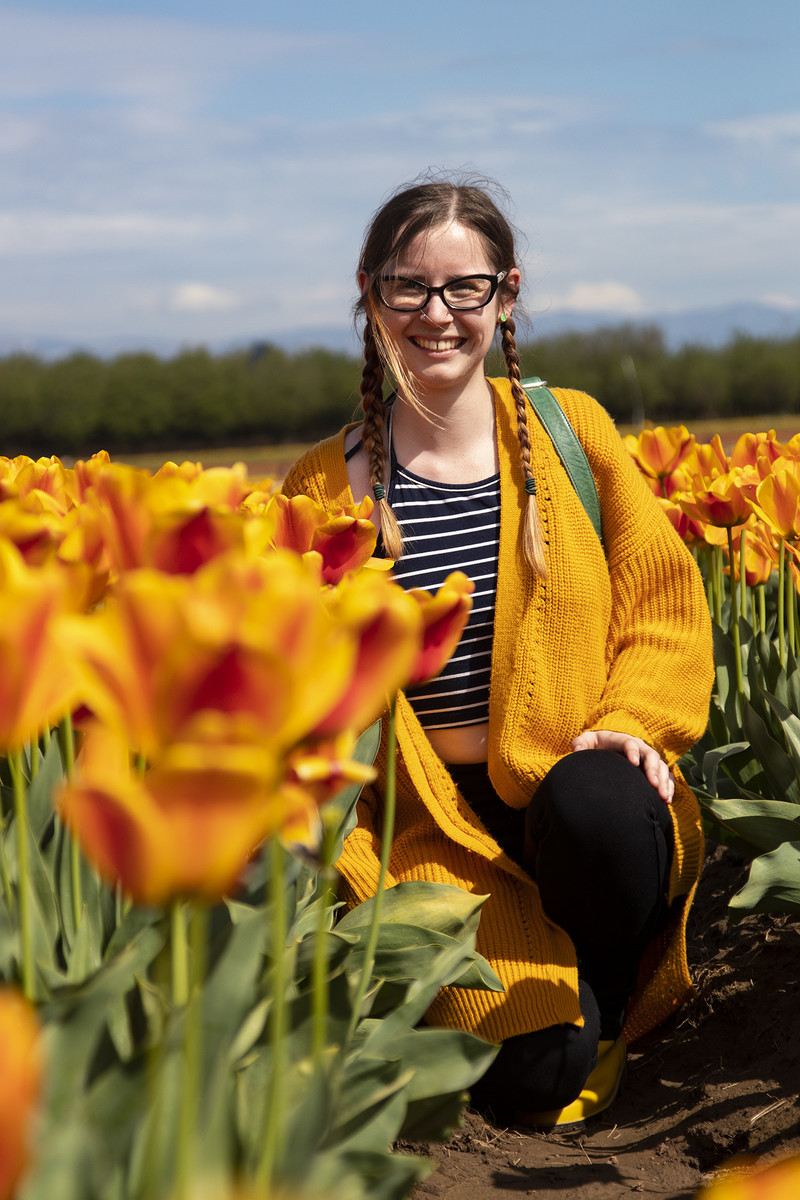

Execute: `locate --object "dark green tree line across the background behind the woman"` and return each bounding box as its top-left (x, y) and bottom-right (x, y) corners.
top-left (0, 325), bottom-right (800, 456)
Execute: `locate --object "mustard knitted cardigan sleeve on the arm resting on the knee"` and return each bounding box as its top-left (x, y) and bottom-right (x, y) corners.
top-left (560, 392), bottom-right (714, 766)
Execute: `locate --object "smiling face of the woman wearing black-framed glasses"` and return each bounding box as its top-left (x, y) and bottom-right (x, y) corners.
top-left (359, 222), bottom-right (519, 396)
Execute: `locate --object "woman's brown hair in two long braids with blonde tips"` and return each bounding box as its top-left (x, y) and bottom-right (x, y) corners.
top-left (355, 181), bottom-right (547, 578)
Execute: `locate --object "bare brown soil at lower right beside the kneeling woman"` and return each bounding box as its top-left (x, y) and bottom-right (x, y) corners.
top-left (413, 845), bottom-right (800, 1200)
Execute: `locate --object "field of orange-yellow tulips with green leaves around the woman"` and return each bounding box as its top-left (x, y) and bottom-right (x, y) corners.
top-left (0, 426), bottom-right (800, 1200)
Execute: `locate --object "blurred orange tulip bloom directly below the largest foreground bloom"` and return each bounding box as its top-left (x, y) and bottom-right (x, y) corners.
top-left (58, 726), bottom-right (303, 904)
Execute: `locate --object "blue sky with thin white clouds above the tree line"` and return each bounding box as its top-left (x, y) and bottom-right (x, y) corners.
top-left (0, 0), bottom-right (800, 346)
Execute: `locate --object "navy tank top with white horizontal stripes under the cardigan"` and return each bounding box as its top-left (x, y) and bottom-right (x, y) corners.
top-left (348, 426), bottom-right (500, 730)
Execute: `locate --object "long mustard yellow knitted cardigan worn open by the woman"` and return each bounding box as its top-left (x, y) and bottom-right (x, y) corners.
top-left (283, 379), bottom-right (712, 1042)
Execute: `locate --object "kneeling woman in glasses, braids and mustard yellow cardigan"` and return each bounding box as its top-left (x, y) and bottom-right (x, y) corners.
top-left (284, 175), bottom-right (712, 1129)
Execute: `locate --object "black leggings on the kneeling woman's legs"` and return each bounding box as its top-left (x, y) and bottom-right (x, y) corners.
top-left (449, 750), bottom-right (673, 1110)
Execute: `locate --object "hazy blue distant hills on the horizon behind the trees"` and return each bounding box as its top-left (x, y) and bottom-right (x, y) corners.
top-left (0, 302), bottom-right (800, 360)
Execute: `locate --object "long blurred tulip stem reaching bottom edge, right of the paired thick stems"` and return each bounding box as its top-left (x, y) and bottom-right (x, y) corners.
top-left (255, 836), bottom-right (287, 1190)
